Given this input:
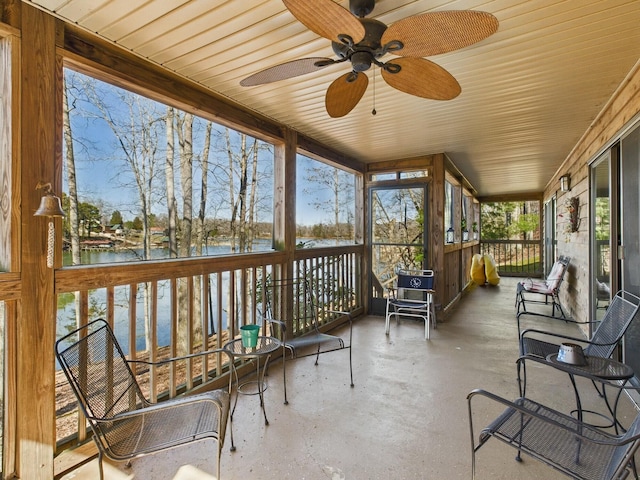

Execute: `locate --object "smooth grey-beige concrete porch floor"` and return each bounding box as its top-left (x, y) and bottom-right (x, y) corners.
top-left (63, 278), bottom-right (634, 480)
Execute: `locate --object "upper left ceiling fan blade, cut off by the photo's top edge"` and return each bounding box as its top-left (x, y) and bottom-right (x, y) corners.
top-left (282, 0), bottom-right (365, 43)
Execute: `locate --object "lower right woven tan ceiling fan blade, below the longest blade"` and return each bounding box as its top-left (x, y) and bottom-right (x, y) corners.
top-left (382, 57), bottom-right (462, 100)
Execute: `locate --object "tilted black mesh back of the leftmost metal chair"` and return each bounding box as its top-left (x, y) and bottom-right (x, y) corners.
top-left (56, 319), bottom-right (148, 428)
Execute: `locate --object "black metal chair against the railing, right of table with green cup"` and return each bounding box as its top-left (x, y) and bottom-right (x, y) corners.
top-left (263, 278), bottom-right (353, 404)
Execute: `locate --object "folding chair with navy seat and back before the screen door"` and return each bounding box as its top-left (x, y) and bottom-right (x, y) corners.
top-left (385, 270), bottom-right (436, 340)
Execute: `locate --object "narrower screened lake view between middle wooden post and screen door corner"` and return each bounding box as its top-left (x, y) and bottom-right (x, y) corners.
top-left (296, 155), bottom-right (356, 248)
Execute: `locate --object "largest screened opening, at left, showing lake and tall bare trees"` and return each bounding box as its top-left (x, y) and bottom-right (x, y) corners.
top-left (62, 70), bottom-right (274, 265)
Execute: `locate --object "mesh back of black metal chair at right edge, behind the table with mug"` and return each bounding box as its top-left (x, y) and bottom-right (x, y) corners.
top-left (584, 291), bottom-right (640, 358)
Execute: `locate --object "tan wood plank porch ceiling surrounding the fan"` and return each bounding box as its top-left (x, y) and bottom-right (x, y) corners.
top-left (30, 0), bottom-right (640, 196)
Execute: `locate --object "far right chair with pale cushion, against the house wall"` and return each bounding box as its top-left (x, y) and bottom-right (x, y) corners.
top-left (516, 256), bottom-right (571, 321)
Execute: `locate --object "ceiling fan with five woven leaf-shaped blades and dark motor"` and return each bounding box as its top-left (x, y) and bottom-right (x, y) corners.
top-left (240, 0), bottom-right (498, 118)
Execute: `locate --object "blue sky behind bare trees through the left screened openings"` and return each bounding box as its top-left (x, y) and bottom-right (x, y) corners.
top-left (63, 70), bottom-right (353, 230)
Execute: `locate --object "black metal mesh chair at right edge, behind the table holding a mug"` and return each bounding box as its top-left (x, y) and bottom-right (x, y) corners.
top-left (518, 291), bottom-right (640, 396)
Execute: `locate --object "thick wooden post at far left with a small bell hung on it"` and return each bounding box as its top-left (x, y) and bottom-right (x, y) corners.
top-left (16, 3), bottom-right (60, 480)
